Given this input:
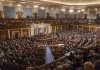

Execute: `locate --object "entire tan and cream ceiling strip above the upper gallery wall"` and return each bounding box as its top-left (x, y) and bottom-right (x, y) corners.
top-left (0, 0), bottom-right (100, 8)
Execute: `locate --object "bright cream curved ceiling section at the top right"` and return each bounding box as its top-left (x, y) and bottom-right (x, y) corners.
top-left (42, 0), bottom-right (100, 5)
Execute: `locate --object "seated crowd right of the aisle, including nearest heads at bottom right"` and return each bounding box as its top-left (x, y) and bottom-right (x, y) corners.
top-left (33, 30), bottom-right (100, 70)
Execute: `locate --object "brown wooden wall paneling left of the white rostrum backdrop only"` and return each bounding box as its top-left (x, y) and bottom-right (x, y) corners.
top-left (0, 28), bottom-right (29, 41)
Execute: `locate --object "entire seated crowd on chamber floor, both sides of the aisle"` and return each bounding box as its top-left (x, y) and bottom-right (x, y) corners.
top-left (0, 30), bottom-right (100, 70)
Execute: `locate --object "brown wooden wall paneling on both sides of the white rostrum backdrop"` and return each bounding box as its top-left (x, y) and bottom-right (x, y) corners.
top-left (0, 24), bottom-right (100, 40)
